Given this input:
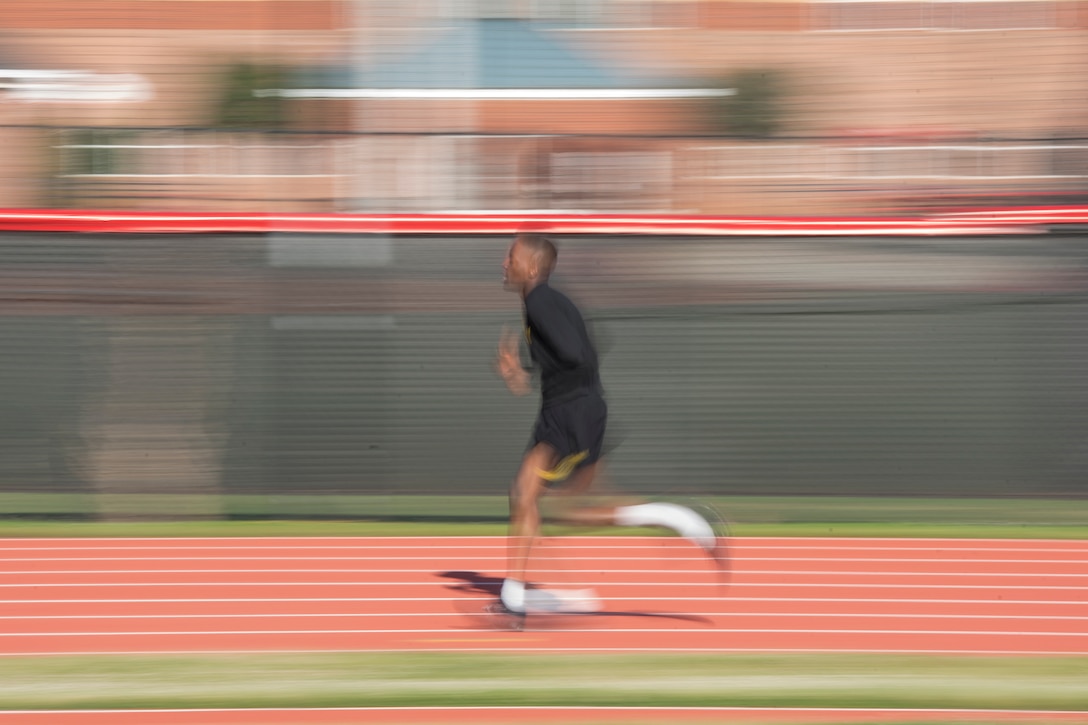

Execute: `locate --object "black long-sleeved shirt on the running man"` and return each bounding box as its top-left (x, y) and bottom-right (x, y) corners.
top-left (524, 282), bottom-right (601, 406)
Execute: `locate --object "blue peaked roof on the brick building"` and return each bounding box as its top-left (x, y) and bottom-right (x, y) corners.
top-left (358, 20), bottom-right (662, 89)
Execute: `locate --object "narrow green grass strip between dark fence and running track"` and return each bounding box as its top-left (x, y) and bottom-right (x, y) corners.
top-left (0, 493), bottom-right (1088, 539)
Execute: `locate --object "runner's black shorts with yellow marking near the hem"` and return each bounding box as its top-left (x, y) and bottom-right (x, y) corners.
top-left (530, 393), bottom-right (608, 482)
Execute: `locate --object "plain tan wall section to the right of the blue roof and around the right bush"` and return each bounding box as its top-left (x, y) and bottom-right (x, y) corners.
top-left (602, 30), bottom-right (1088, 135)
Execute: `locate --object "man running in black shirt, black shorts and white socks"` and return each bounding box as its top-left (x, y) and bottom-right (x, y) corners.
top-left (496, 234), bottom-right (722, 614)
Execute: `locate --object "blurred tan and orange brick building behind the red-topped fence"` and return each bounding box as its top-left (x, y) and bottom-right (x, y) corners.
top-left (0, 0), bottom-right (1088, 213)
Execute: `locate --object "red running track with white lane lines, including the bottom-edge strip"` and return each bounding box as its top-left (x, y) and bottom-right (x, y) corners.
top-left (0, 537), bottom-right (1088, 725)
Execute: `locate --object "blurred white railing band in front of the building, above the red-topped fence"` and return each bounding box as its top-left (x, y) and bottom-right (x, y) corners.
top-left (57, 132), bottom-right (1088, 211)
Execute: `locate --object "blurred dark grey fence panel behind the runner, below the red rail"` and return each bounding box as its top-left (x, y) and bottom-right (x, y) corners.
top-left (0, 229), bottom-right (1088, 508)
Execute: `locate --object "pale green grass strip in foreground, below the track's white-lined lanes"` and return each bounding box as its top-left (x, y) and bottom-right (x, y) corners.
top-left (0, 653), bottom-right (1088, 710)
